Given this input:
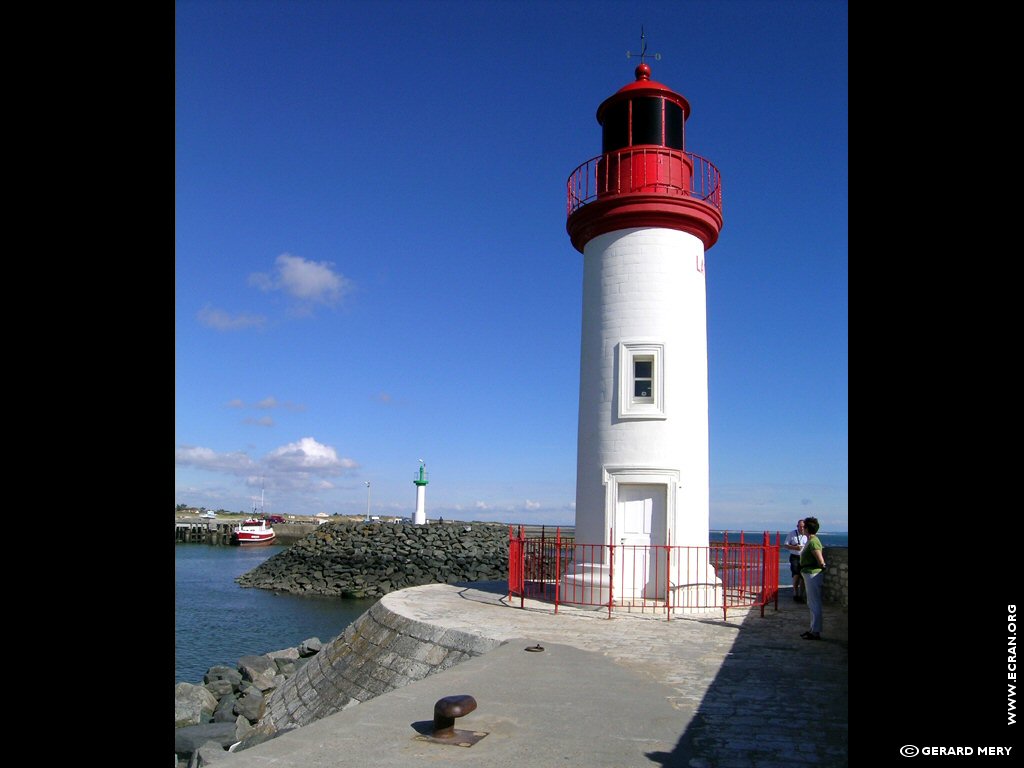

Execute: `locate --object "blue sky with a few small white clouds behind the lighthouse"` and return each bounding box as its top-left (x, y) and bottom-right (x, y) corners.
top-left (174, 0), bottom-right (849, 531)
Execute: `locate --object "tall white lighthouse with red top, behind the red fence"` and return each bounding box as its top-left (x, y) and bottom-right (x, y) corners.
top-left (565, 55), bottom-right (723, 605)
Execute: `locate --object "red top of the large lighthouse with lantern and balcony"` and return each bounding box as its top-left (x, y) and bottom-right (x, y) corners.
top-left (565, 62), bottom-right (722, 253)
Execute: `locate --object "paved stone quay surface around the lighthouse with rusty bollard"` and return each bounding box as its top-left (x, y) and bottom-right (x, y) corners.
top-left (217, 583), bottom-right (849, 768)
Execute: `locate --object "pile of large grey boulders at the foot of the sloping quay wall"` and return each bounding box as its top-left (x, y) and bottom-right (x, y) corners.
top-left (174, 637), bottom-right (322, 768)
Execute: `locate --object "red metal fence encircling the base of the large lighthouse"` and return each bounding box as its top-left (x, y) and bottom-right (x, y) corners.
top-left (508, 526), bottom-right (780, 620)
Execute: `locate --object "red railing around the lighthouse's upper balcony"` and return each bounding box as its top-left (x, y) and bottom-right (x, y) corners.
top-left (566, 146), bottom-right (722, 216)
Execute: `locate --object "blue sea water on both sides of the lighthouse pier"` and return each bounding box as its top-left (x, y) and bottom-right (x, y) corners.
top-left (174, 530), bottom-right (849, 683)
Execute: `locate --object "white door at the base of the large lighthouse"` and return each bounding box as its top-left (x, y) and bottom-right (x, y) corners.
top-left (612, 483), bottom-right (669, 599)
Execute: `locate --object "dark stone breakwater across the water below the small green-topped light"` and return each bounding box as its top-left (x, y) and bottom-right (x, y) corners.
top-left (236, 521), bottom-right (509, 598)
